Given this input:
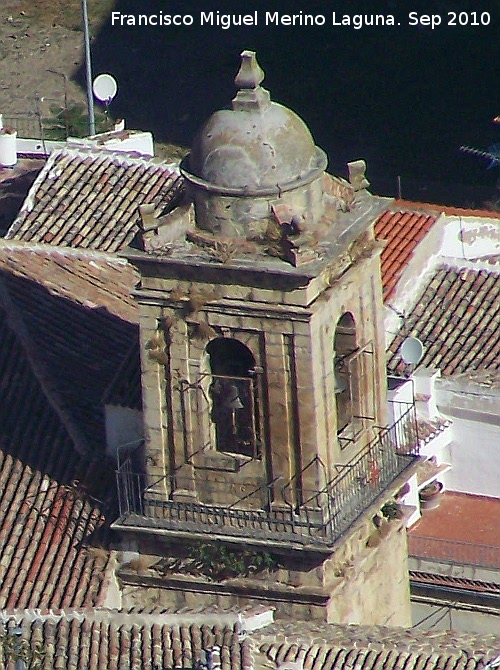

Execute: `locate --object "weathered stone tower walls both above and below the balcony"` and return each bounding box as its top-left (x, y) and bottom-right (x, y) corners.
top-left (122, 209), bottom-right (410, 625)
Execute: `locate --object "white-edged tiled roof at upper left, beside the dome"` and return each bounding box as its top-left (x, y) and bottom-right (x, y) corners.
top-left (6, 148), bottom-right (183, 253)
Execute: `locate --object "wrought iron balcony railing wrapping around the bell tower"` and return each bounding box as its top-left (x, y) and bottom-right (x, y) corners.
top-left (114, 403), bottom-right (419, 551)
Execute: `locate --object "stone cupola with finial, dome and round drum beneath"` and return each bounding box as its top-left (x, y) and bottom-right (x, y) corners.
top-left (182, 51), bottom-right (327, 238)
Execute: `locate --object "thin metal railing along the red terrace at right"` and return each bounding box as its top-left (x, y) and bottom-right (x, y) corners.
top-left (408, 533), bottom-right (500, 569)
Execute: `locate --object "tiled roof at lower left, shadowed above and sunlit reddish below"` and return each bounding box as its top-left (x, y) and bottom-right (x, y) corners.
top-left (0, 310), bottom-right (110, 607)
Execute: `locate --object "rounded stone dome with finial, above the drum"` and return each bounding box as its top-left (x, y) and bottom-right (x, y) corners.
top-left (185, 51), bottom-right (327, 195)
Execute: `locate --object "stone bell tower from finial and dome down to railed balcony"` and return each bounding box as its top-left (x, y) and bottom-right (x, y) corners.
top-left (116, 51), bottom-right (417, 623)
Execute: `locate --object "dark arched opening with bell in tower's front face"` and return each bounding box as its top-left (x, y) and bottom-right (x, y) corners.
top-left (207, 337), bottom-right (261, 458)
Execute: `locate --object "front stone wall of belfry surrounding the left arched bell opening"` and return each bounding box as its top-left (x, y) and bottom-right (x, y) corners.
top-left (138, 284), bottom-right (317, 503)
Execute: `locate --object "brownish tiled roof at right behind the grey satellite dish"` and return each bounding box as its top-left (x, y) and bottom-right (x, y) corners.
top-left (389, 267), bottom-right (500, 375)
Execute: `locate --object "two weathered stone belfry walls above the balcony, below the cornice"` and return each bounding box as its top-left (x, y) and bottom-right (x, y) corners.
top-left (135, 234), bottom-right (385, 502)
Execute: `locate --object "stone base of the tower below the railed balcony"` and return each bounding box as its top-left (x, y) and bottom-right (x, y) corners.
top-left (119, 504), bottom-right (411, 626)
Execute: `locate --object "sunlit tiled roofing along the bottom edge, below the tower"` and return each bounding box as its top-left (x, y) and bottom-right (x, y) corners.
top-left (0, 610), bottom-right (500, 670)
